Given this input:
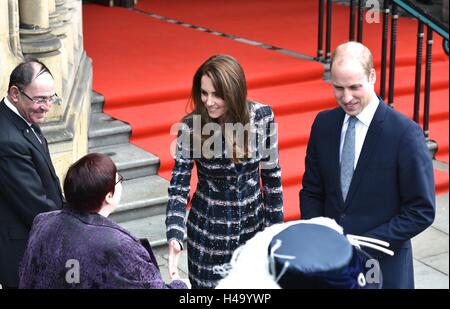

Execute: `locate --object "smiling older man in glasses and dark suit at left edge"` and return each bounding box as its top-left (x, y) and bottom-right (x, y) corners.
top-left (0, 59), bottom-right (63, 288)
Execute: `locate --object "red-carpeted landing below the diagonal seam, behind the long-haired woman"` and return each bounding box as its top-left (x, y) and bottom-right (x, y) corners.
top-left (83, 5), bottom-right (323, 112)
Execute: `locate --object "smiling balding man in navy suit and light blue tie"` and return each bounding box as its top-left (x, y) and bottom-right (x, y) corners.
top-left (300, 42), bottom-right (435, 288)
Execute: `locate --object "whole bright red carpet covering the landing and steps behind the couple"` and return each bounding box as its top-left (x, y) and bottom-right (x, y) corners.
top-left (83, 0), bottom-right (449, 220)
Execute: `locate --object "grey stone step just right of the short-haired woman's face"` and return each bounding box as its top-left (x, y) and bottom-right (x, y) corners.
top-left (111, 175), bottom-right (169, 222)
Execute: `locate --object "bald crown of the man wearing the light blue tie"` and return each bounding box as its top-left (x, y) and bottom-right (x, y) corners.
top-left (330, 42), bottom-right (373, 77)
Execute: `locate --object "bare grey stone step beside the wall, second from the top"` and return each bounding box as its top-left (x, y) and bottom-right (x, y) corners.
top-left (89, 113), bottom-right (131, 149)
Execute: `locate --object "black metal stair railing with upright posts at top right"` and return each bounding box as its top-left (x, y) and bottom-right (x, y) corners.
top-left (317, 0), bottom-right (449, 157)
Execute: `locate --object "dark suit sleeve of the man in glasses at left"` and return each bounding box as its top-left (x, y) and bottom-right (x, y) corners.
top-left (0, 142), bottom-right (59, 228)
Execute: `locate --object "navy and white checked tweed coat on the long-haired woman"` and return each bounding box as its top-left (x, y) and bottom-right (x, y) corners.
top-left (166, 102), bottom-right (284, 288)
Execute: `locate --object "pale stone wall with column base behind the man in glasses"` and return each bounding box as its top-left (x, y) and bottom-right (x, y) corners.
top-left (0, 0), bottom-right (92, 181)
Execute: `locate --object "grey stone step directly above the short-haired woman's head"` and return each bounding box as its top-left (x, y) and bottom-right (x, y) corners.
top-left (89, 143), bottom-right (159, 180)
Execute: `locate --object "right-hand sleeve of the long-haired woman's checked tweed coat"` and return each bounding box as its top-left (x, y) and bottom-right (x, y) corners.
top-left (260, 110), bottom-right (284, 226)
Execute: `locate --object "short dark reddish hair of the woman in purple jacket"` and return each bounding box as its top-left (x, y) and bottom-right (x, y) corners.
top-left (64, 153), bottom-right (117, 212)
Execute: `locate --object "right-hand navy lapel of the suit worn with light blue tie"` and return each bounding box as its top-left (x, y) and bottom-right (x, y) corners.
top-left (341, 99), bottom-right (388, 209)
